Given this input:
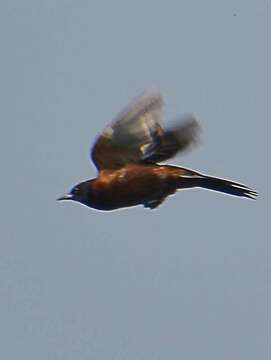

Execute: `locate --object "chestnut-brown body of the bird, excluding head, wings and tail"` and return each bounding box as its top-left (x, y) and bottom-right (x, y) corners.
top-left (70, 165), bottom-right (181, 210)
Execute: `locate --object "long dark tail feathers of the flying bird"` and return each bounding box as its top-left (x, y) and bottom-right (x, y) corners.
top-left (195, 176), bottom-right (258, 199)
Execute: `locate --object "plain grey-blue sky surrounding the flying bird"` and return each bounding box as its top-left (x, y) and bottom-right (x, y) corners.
top-left (0, 0), bottom-right (271, 360)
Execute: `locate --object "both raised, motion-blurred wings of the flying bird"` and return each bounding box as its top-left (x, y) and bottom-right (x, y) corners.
top-left (91, 91), bottom-right (199, 170)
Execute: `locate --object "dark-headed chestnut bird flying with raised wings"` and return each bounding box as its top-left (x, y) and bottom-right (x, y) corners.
top-left (57, 90), bottom-right (258, 211)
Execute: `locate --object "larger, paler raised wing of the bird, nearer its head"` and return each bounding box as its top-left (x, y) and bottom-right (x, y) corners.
top-left (91, 91), bottom-right (163, 170)
